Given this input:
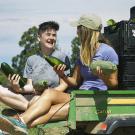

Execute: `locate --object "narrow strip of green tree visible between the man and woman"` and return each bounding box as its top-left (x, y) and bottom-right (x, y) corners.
top-left (70, 37), bottom-right (80, 67)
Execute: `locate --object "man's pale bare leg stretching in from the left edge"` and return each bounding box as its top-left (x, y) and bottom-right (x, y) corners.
top-left (0, 86), bottom-right (29, 111)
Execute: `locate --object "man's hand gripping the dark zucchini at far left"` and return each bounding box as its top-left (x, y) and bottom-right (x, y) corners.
top-left (8, 74), bottom-right (20, 93)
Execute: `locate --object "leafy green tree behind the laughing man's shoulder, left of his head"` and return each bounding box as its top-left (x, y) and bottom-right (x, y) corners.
top-left (12, 26), bottom-right (39, 74)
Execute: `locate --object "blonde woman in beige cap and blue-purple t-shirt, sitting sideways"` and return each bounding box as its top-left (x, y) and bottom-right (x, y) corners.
top-left (0, 15), bottom-right (118, 134)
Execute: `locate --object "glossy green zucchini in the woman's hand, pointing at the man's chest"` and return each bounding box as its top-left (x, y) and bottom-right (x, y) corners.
top-left (44, 55), bottom-right (70, 70)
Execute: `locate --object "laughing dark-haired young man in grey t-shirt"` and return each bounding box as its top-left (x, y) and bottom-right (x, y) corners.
top-left (0, 21), bottom-right (69, 111)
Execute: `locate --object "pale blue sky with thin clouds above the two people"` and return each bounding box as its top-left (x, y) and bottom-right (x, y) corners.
top-left (0, 0), bottom-right (135, 64)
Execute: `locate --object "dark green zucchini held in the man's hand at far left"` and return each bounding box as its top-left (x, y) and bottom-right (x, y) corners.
top-left (1, 62), bottom-right (27, 88)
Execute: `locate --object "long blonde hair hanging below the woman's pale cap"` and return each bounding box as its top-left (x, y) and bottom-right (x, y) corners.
top-left (78, 25), bottom-right (100, 66)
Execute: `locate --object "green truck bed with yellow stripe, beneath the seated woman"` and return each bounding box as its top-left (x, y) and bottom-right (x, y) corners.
top-left (39, 90), bottom-right (135, 134)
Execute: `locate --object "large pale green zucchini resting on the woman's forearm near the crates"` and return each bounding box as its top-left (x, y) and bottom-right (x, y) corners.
top-left (90, 60), bottom-right (117, 74)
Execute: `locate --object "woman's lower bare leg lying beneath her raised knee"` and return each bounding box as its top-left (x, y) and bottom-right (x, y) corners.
top-left (29, 103), bottom-right (69, 127)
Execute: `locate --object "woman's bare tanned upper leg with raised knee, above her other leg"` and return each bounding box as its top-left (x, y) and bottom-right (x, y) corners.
top-left (21, 89), bottom-right (70, 124)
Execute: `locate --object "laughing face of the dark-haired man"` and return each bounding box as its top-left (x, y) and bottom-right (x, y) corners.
top-left (39, 29), bottom-right (57, 49)
